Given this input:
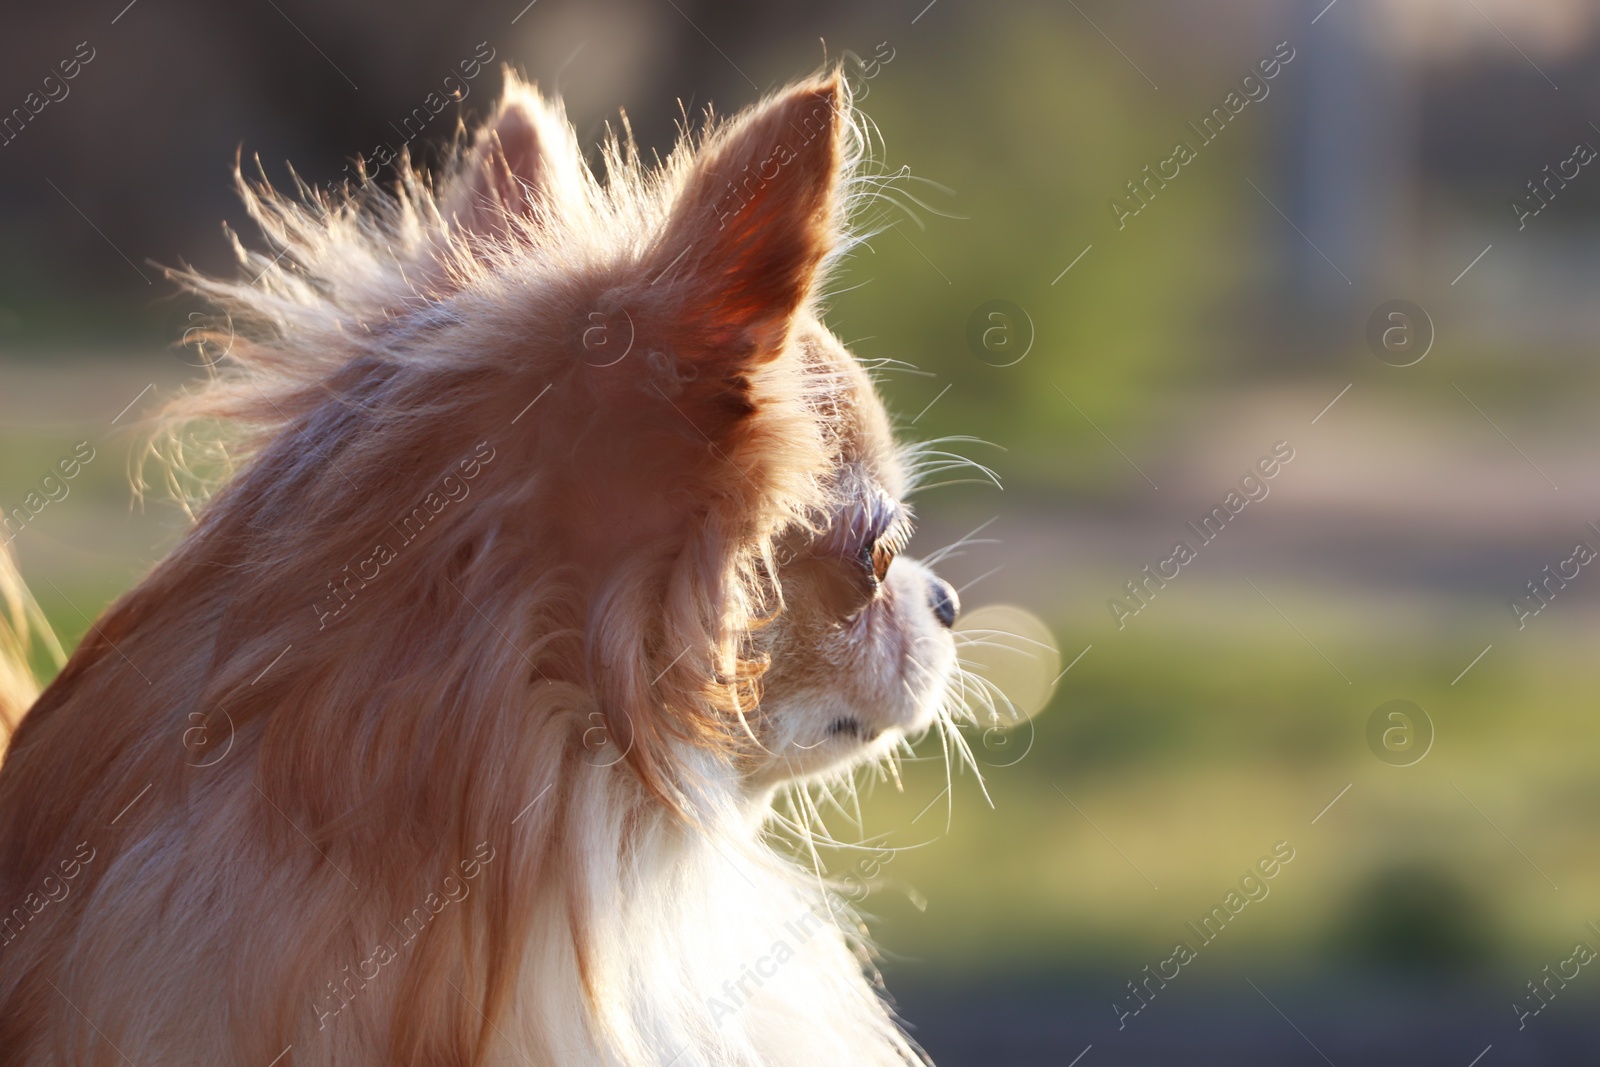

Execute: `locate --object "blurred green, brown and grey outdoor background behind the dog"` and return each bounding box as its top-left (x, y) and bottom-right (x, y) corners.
top-left (0, 0), bottom-right (1600, 1067)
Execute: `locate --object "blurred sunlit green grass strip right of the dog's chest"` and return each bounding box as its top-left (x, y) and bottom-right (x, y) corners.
top-left (838, 607), bottom-right (1600, 968)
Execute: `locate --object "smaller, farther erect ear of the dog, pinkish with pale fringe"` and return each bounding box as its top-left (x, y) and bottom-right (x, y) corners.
top-left (442, 70), bottom-right (586, 237)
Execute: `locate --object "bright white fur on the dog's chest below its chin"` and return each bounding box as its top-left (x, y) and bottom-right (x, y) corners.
top-left (492, 758), bottom-right (915, 1067)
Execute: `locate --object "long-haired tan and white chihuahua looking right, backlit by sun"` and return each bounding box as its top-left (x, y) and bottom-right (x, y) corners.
top-left (0, 74), bottom-right (957, 1067)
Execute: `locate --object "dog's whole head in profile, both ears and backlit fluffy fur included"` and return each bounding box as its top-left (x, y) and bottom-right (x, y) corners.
top-left (192, 77), bottom-right (957, 806)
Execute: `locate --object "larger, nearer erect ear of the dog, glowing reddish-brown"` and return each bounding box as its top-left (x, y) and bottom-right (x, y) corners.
top-left (650, 77), bottom-right (846, 360)
